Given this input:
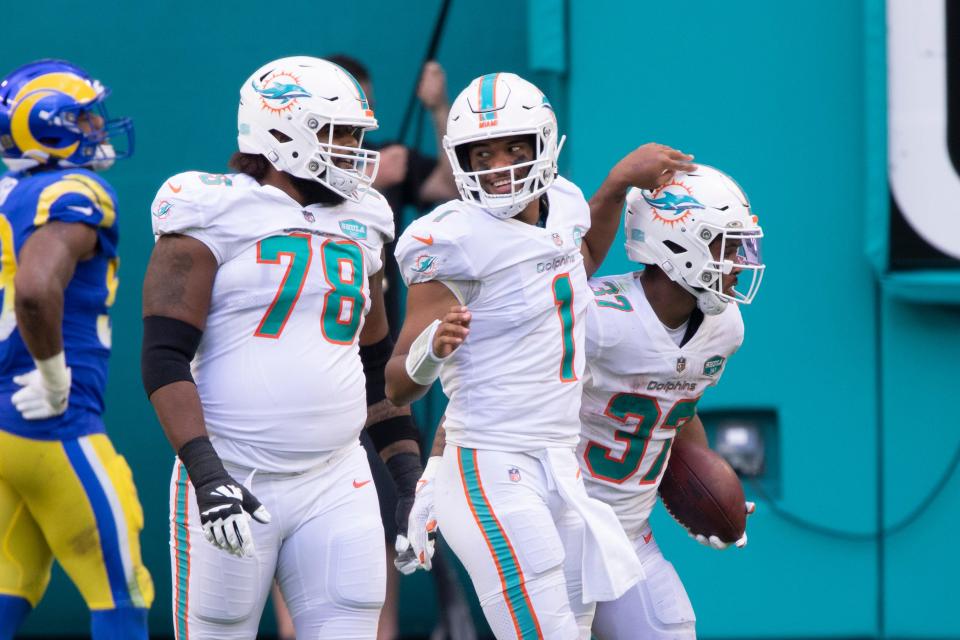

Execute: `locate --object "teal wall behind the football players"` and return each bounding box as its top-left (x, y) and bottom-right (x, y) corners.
top-left (0, 0), bottom-right (960, 638)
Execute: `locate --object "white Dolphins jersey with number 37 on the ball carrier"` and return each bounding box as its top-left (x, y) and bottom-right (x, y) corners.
top-left (577, 273), bottom-right (743, 537)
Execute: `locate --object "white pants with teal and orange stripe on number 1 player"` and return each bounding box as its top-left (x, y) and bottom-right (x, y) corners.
top-left (434, 444), bottom-right (594, 640)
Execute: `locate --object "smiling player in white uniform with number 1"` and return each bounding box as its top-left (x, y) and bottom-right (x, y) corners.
top-left (387, 73), bottom-right (693, 639)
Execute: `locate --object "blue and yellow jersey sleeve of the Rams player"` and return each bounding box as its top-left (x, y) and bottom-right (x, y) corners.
top-left (33, 170), bottom-right (119, 258)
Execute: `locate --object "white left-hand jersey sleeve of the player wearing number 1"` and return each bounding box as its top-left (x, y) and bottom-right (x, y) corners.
top-left (396, 207), bottom-right (479, 287)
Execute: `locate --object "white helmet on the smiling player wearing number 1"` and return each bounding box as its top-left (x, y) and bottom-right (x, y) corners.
top-left (443, 73), bottom-right (565, 218)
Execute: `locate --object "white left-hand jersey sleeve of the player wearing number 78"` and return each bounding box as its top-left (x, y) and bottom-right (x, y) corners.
top-left (150, 171), bottom-right (235, 264)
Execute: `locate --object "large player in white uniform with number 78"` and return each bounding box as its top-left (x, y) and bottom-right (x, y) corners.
top-left (142, 57), bottom-right (421, 640)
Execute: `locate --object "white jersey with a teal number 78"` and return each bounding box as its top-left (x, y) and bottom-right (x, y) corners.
top-left (152, 172), bottom-right (393, 471)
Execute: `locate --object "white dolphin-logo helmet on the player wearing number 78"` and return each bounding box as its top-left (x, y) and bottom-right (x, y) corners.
top-left (237, 56), bottom-right (380, 202)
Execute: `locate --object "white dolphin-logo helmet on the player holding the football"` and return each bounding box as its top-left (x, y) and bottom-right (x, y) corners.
top-left (624, 164), bottom-right (765, 315)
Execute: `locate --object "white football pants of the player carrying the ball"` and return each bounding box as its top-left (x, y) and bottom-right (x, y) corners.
top-left (593, 528), bottom-right (697, 640)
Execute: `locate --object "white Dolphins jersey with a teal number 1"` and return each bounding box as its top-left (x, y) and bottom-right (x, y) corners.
top-left (397, 177), bottom-right (592, 451)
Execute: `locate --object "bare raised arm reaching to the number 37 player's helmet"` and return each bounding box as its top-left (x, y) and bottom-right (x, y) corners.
top-left (580, 142), bottom-right (696, 277)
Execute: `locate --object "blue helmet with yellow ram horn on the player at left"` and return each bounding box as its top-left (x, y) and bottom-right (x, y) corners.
top-left (0, 60), bottom-right (133, 170)
